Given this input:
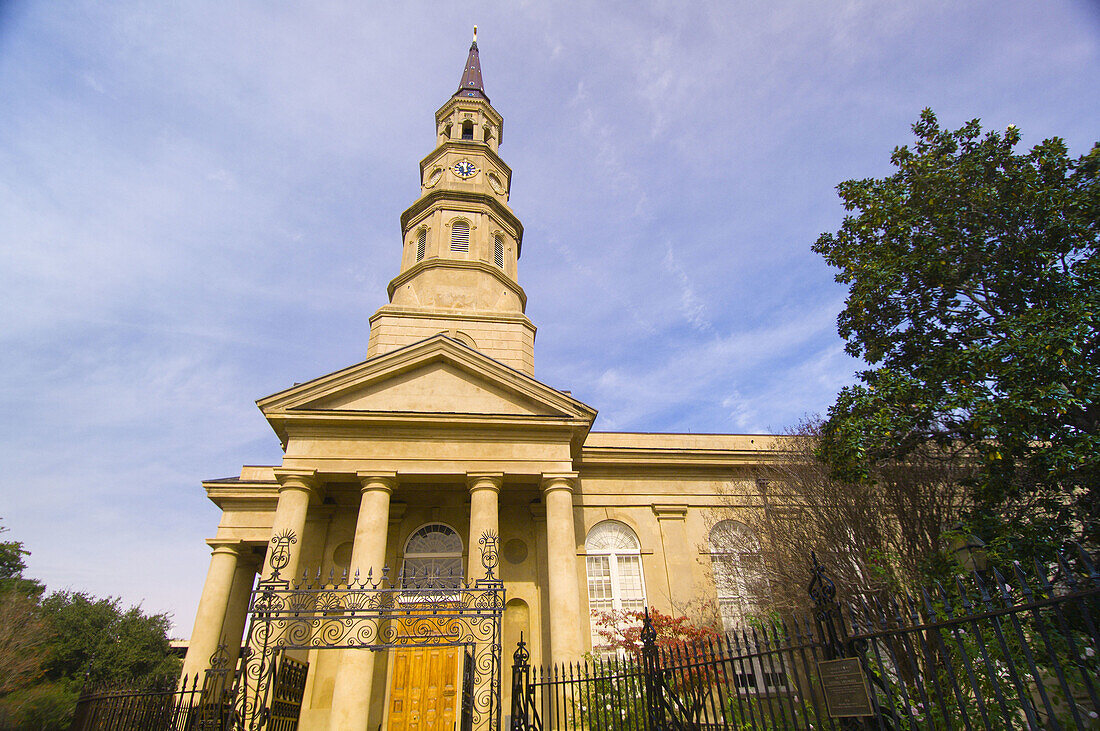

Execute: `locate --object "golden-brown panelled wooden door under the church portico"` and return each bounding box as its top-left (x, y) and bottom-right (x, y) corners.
top-left (387, 646), bottom-right (463, 731)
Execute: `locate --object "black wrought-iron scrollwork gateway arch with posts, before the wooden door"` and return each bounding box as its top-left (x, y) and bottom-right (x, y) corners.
top-left (237, 531), bottom-right (504, 731)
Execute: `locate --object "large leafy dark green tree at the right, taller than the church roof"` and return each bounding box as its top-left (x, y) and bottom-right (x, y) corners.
top-left (814, 110), bottom-right (1100, 552)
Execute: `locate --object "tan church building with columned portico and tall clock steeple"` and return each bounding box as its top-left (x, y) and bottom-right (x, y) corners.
top-left (184, 35), bottom-right (778, 730)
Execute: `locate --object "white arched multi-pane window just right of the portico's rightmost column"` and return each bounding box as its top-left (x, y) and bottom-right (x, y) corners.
top-left (584, 520), bottom-right (646, 646)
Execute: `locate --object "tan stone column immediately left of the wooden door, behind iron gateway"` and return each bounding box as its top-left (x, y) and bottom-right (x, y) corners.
top-left (329, 473), bottom-right (397, 731)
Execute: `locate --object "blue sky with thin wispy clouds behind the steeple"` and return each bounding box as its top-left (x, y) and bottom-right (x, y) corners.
top-left (0, 0), bottom-right (1100, 636)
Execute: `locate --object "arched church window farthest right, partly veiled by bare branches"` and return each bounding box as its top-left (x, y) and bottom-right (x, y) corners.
top-left (707, 520), bottom-right (762, 632)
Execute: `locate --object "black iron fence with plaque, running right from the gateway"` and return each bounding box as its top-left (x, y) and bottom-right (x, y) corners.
top-left (510, 551), bottom-right (1100, 731)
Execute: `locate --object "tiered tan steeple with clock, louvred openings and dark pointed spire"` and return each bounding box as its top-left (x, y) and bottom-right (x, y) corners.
top-left (366, 26), bottom-right (535, 375)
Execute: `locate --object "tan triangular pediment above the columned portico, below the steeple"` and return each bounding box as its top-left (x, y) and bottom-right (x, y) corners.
top-left (259, 335), bottom-right (595, 422)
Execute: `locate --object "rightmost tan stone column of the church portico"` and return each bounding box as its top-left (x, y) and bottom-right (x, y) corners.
top-left (542, 473), bottom-right (586, 663)
